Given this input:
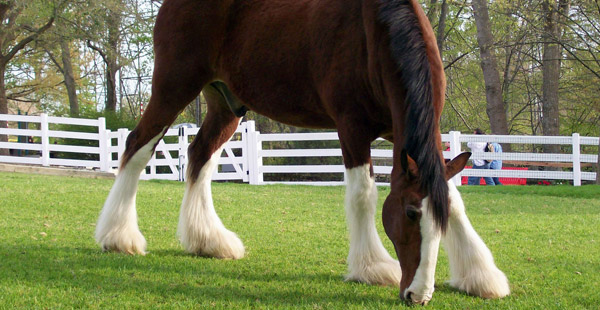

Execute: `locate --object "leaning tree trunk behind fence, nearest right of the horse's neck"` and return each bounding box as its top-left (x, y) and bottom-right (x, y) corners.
top-left (472, 0), bottom-right (510, 138)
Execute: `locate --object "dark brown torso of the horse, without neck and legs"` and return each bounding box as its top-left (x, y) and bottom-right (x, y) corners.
top-left (150, 0), bottom-right (440, 136)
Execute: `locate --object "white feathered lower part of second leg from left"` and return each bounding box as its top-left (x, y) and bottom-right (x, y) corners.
top-left (177, 149), bottom-right (245, 259)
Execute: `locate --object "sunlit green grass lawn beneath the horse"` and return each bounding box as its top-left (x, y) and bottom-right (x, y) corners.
top-left (0, 173), bottom-right (600, 309)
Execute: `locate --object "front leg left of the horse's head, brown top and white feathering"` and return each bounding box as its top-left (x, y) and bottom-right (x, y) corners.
top-left (338, 124), bottom-right (402, 286)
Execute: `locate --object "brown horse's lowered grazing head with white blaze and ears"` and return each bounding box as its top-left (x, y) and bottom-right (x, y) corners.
top-left (382, 151), bottom-right (471, 304)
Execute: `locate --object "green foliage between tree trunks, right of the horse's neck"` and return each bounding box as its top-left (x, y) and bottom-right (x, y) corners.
top-left (433, 0), bottom-right (600, 136)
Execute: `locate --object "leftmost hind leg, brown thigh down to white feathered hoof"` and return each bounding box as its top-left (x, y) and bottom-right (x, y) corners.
top-left (95, 30), bottom-right (212, 254)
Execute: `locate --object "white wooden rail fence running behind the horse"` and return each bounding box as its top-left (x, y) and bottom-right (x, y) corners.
top-left (0, 114), bottom-right (599, 186)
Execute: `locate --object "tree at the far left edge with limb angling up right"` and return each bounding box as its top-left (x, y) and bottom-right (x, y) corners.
top-left (0, 0), bottom-right (55, 155)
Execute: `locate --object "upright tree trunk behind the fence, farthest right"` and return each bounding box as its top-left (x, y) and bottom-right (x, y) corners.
top-left (542, 0), bottom-right (568, 153)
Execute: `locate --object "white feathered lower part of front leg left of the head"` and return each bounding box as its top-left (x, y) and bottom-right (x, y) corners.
top-left (345, 164), bottom-right (402, 286)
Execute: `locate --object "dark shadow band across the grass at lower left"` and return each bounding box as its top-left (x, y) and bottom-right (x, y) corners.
top-left (0, 245), bottom-right (401, 308)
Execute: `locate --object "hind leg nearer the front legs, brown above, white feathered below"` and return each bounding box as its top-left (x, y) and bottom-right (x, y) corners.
top-left (177, 86), bottom-right (244, 259)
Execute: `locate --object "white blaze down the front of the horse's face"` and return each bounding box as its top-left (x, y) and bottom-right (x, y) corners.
top-left (404, 197), bottom-right (441, 304)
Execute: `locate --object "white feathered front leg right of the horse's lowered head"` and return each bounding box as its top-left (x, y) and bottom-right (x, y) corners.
top-left (442, 182), bottom-right (510, 298)
